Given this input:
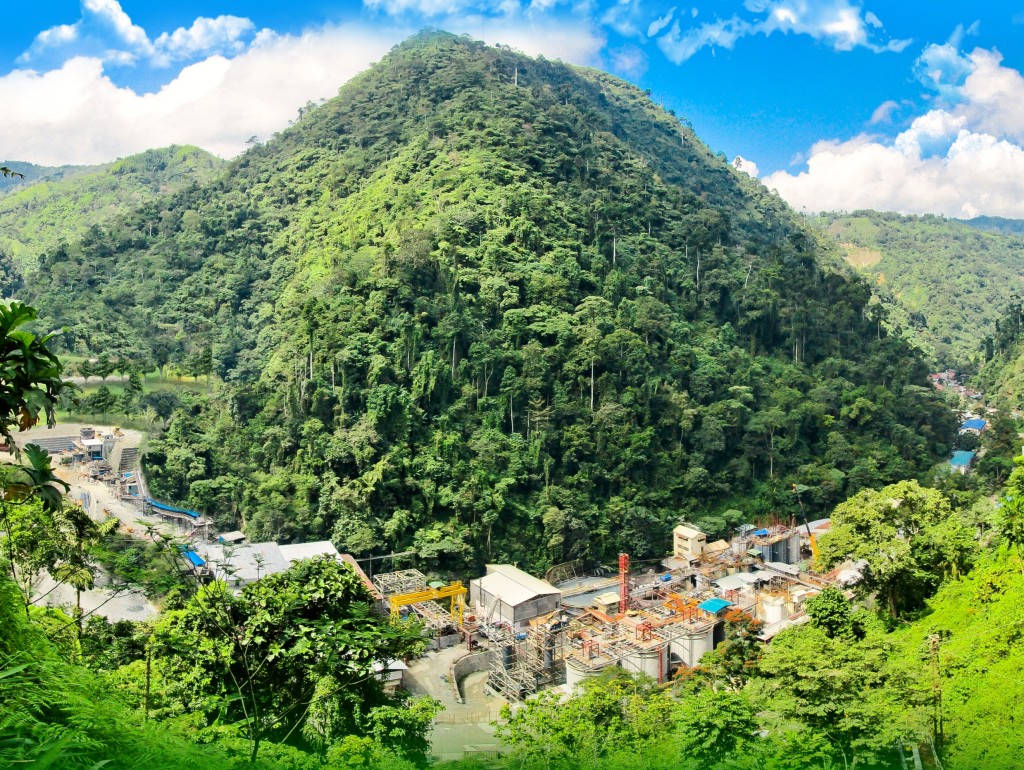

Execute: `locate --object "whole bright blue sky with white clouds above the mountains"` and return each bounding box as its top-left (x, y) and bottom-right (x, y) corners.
top-left (6, 0), bottom-right (1024, 216)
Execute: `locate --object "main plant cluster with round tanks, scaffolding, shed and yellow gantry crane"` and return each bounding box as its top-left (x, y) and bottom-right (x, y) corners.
top-left (373, 520), bottom-right (856, 702)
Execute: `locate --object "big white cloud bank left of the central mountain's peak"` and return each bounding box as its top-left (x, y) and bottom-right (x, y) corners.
top-left (0, 27), bottom-right (404, 164)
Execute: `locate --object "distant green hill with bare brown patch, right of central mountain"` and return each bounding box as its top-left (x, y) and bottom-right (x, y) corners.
top-left (814, 211), bottom-right (1024, 369)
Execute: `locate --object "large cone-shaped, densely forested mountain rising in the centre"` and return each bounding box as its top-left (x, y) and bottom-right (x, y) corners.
top-left (22, 34), bottom-right (953, 571)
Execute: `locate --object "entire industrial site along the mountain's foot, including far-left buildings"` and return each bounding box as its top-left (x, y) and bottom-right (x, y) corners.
top-left (14, 427), bottom-right (858, 703)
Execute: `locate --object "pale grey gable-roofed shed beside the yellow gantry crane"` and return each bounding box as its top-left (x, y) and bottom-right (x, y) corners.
top-left (469, 564), bottom-right (562, 629)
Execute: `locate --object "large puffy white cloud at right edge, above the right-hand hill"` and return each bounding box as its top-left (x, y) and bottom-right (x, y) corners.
top-left (764, 44), bottom-right (1024, 217)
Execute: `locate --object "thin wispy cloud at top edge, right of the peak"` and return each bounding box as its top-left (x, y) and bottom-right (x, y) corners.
top-left (648, 0), bottom-right (910, 63)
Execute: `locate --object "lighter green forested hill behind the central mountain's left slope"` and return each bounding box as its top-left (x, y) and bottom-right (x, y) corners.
top-left (0, 146), bottom-right (225, 276)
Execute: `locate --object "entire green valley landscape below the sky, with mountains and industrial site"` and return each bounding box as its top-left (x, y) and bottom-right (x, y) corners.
top-left (0, 24), bottom-right (1024, 770)
